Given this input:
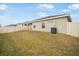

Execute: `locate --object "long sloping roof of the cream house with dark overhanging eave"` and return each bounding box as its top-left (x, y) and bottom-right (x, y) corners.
top-left (24, 14), bottom-right (72, 24)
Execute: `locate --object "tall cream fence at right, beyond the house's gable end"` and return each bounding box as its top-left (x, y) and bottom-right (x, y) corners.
top-left (67, 22), bottom-right (79, 37)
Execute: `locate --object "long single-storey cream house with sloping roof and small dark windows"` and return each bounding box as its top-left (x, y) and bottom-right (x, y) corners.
top-left (23, 14), bottom-right (72, 33)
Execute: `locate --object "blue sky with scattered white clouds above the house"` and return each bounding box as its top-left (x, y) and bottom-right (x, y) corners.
top-left (0, 3), bottom-right (79, 26)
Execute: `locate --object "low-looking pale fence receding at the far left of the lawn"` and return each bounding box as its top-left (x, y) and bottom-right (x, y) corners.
top-left (0, 26), bottom-right (27, 33)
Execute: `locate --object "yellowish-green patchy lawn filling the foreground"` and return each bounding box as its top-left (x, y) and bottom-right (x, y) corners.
top-left (0, 31), bottom-right (79, 56)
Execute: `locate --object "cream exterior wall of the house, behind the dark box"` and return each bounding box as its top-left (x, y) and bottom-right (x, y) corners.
top-left (32, 17), bottom-right (68, 33)
